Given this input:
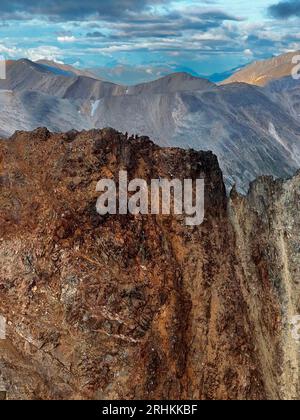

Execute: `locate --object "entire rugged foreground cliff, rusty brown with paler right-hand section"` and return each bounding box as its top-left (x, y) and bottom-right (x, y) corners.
top-left (0, 129), bottom-right (299, 399)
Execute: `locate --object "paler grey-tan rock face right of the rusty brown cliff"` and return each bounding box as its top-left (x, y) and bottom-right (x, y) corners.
top-left (230, 173), bottom-right (300, 399)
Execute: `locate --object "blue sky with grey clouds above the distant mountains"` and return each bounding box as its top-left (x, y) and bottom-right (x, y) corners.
top-left (0, 0), bottom-right (300, 81)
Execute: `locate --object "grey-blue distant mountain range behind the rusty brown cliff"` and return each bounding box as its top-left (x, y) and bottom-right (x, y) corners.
top-left (0, 53), bottom-right (300, 191)
